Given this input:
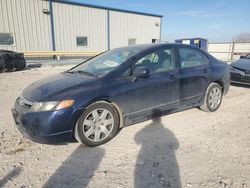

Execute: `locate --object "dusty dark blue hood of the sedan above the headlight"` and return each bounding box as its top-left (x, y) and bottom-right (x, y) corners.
top-left (22, 72), bottom-right (96, 102)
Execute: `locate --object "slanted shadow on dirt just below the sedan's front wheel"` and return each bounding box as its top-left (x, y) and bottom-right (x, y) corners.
top-left (43, 145), bottom-right (105, 188)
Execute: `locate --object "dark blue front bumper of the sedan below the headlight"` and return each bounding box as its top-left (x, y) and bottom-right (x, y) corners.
top-left (12, 100), bottom-right (75, 144)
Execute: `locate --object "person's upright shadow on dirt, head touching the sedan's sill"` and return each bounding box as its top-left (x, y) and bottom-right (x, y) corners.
top-left (134, 118), bottom-right (181, 188)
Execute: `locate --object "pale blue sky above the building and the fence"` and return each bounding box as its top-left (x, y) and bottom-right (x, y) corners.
top-left (71, 0), bottom-right (250, 42)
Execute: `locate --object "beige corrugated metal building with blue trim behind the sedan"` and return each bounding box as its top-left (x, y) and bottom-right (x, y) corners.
top-left (0, 0), bottom-right (162, 52)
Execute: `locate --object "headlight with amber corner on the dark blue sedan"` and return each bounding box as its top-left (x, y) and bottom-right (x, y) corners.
top-left (31, 100), bottom-right (74, 112)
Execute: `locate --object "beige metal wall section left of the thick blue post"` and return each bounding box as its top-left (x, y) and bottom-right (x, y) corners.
top-left (0, 0), bottom-right (51, 51)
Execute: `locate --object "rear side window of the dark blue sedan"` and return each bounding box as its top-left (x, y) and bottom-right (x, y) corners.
top-left (179, 48), bottom-right (209, 68)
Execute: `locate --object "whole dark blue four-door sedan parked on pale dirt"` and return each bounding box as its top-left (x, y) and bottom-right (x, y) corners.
top-left (12, 44), bottom-right (230, 146)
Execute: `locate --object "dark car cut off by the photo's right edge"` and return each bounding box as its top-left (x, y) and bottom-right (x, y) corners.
top-left (230, 54), bottom-right (250, 85)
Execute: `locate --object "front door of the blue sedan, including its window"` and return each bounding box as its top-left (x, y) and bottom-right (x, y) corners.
top-left (111, 48), bottom-right (180, 124)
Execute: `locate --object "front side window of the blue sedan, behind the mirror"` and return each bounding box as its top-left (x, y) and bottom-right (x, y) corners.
top-left (135, 49), bottom-right (175, 73)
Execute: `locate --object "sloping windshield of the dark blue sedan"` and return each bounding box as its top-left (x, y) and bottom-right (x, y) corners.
top-left (69, 46), bottom-right (142, 76)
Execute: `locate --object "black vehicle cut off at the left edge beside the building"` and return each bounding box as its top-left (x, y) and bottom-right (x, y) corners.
top-left (0, 50), bottom-right (26, 71)
